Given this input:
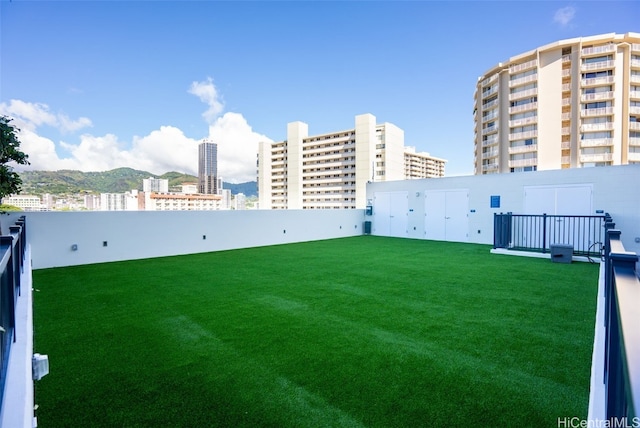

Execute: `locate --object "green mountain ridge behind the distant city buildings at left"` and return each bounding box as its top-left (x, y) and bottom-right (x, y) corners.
top-left (19, 168), bottom-right (258, 196)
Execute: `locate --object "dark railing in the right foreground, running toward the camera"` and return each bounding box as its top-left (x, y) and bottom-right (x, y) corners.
top-left (604, 227), bottom-right (640, 418)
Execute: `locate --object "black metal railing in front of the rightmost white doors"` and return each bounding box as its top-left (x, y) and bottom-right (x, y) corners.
top-left (493, 213), bottom-right (607, 257)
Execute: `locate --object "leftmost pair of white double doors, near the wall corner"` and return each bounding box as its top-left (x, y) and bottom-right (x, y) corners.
top-left (372, 191), bottom-right (409, 237)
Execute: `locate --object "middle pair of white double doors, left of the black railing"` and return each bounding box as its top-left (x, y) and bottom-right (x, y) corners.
top-left (424, 190), bottom-right (469, 242)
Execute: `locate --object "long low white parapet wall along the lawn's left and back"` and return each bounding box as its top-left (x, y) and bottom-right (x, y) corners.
top-left (0, 210), bottom-right (364, 269)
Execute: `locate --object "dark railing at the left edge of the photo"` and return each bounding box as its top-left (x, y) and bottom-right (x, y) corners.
top-left (0, 217), bottom-right (27, 406)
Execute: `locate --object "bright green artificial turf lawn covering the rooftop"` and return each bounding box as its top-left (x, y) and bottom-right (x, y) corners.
top-left (33, 236), bottom-right (598, 428)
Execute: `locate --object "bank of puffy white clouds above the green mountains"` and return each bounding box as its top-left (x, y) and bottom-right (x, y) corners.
top-left (0, 79), bottom-right (272, 183)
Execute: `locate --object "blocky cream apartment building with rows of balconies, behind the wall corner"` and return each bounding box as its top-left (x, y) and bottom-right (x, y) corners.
top-left (257, 114), bottom-right (444, 209)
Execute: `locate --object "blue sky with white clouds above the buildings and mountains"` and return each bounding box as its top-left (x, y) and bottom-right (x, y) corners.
top-left (0, 0), bottom-right (640, 182)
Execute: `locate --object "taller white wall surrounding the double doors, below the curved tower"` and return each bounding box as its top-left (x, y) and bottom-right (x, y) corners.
top-left (366, 165), bottom-right (640, 253)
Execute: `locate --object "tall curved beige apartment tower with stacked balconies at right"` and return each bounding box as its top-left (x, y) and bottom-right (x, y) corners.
top-left (474, 33), bottom-right (640, 174)
